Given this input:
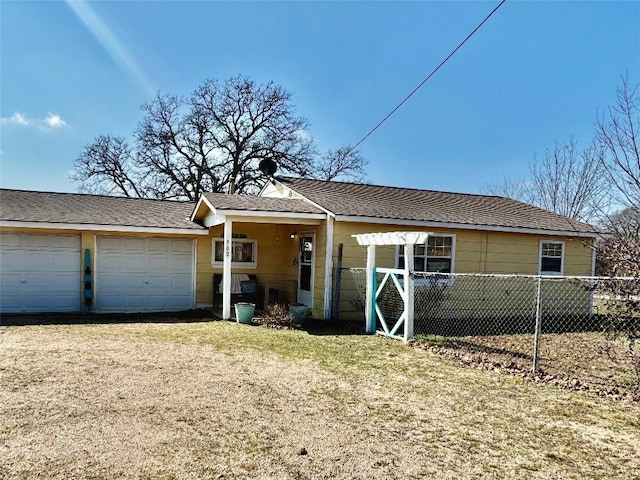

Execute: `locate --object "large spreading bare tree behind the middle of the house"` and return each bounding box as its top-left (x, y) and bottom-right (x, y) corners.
top-left (72, 76), bottom-right (365, 200)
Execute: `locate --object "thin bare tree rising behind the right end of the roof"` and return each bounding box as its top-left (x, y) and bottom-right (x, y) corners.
top-left (484, 138), bottom-right (607, 221)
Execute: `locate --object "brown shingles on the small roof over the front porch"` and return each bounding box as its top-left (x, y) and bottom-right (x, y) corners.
top-left (204, 193), bottom-right (324, 213)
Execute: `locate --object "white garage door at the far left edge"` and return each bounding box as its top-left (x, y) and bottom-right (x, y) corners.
top-left (0, 232), bottom-right (82, 313)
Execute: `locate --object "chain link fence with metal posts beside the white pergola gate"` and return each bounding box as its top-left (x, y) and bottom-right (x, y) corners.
top-left (339, 269), bottom-right (640, 393)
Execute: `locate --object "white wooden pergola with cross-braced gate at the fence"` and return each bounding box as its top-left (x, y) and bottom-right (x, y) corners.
top-left (352, 232), bottom-right (429, 342)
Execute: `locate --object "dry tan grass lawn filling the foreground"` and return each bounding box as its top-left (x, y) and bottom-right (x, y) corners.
top-left (0, 322), bottom-right (640, 479)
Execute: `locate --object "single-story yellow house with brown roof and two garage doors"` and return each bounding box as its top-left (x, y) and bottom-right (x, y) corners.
top-left (0, 177), bottom-right (597, 319)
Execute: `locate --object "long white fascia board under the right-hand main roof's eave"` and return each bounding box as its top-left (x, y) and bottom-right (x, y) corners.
top-left (336, 215), bottom-right (600, 238)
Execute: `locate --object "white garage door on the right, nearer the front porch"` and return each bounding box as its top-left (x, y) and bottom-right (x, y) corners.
top-left (95, 236), bottom-right (194, 312)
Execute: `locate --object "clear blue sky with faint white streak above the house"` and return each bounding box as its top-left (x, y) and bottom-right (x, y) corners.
top-left (0, 0), bottom-right (640, 193)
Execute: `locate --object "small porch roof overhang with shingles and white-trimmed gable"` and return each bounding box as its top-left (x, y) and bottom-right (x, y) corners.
top-left (191, 193), bottom-right (327, 227)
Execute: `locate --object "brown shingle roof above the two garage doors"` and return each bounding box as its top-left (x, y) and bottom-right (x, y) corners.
top-left (0, 189), bottom-right (203, 230)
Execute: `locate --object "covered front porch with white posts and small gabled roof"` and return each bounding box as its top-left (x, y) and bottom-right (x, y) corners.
top-left (193, 194), bottom-right (333, 319)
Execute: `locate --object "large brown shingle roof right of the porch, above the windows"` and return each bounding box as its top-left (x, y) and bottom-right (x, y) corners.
top-left (278, 177), bottom-right (596, 233)
